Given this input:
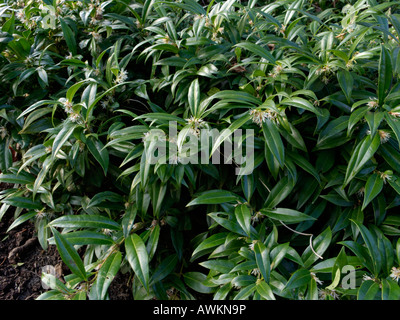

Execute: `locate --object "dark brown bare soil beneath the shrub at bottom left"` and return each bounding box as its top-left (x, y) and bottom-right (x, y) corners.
top-left (0, 185), bottom-right (133, 300)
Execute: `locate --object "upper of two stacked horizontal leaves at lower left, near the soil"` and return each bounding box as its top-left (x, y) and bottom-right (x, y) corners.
top-left (50, 214), bottom-right (121, 230)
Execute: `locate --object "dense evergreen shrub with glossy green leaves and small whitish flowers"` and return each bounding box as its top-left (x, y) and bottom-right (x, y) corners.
top-left (0, 0), bottom-right (400, 300)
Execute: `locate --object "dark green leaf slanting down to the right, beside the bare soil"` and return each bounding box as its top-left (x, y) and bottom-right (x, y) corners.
top-left (51, 227), bottom-right (87, 281)
